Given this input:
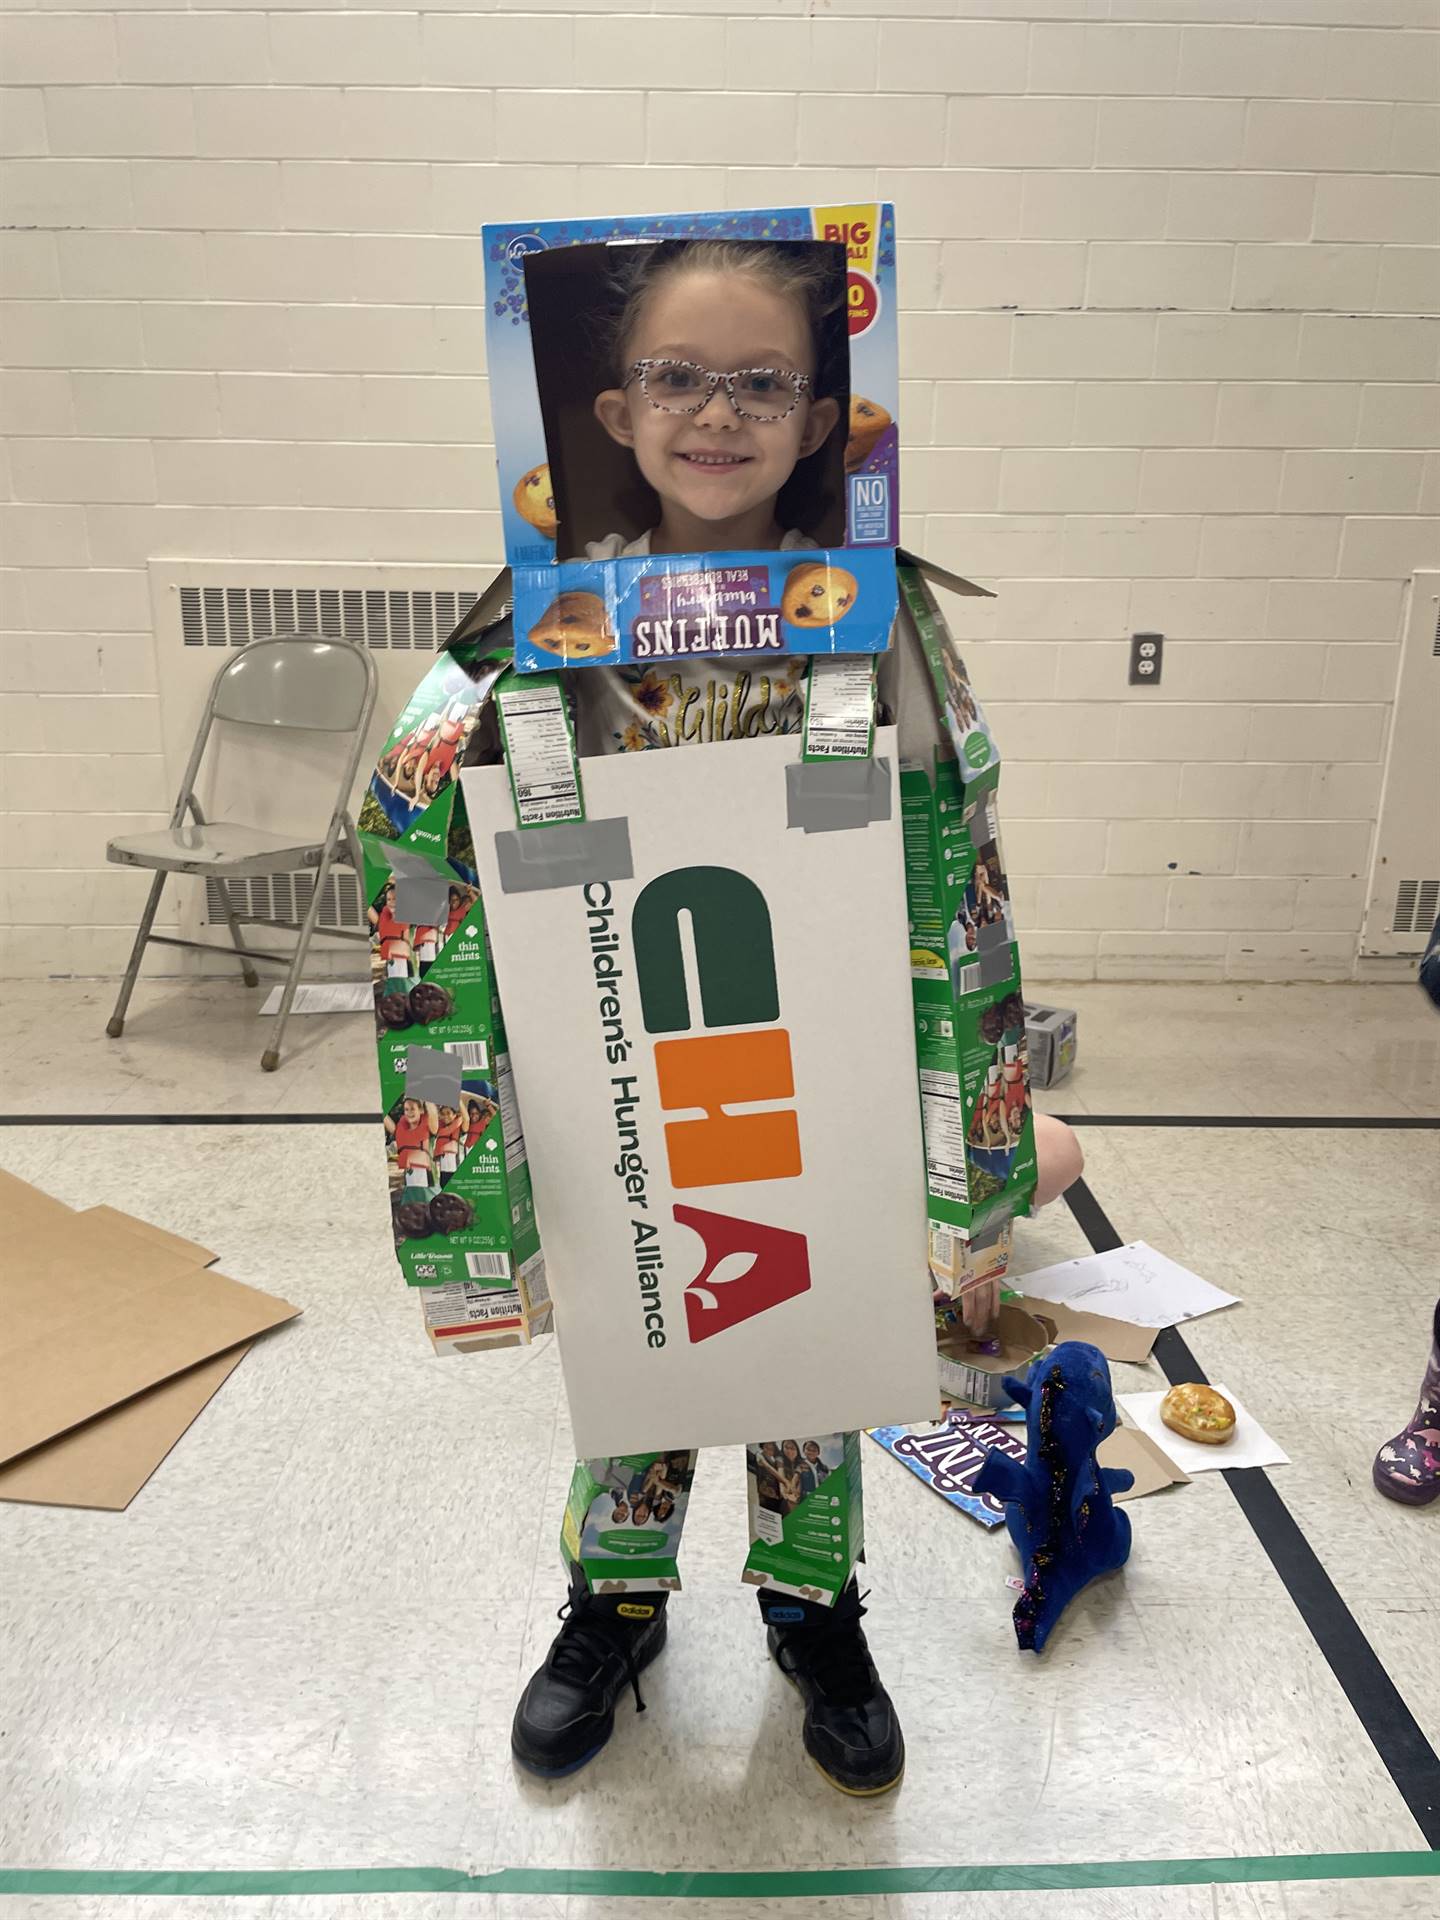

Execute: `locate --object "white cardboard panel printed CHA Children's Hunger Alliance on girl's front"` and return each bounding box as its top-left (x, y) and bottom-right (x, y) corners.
top-left (461, 728), bottom-right (937, 1457)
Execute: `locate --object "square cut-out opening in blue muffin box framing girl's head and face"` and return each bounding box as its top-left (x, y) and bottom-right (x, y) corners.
top-left (524, 240), bottom-right (849, 559)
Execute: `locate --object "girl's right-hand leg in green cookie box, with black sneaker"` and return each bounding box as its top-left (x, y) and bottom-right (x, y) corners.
top-left (745, 1432), bottom-right (904, 1795)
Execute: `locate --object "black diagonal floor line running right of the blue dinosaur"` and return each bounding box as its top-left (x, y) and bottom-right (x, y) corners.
top-left (1066, 1179), bottom-right (1440, 1849)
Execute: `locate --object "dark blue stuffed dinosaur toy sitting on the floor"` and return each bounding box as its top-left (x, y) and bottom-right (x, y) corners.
top-left (975, 1340), bottom-right (1135, 1653)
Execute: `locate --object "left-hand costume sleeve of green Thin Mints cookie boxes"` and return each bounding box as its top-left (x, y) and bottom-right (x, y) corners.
top-left (359, 572), bottom-right (549, 1352)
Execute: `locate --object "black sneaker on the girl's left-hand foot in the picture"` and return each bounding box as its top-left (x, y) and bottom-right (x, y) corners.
top-left (511, 1576), bottom-right (670, 1778)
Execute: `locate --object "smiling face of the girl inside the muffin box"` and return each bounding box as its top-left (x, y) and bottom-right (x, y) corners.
top-left (595, 271), bottom-right (839, 553)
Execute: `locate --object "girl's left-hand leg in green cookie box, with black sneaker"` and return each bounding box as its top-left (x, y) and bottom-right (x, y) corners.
top-left (511, 1453), bottom-right (697, 1776)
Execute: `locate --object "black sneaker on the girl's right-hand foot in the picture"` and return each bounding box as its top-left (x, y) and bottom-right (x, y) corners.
top-left (760, 1580), bottom-right (904, 1797)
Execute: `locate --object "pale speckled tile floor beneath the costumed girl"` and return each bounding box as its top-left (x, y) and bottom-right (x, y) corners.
top-left (0, 981), bottom-right (1440, 1920)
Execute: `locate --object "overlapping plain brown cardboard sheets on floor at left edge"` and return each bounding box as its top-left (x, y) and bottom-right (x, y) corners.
top-left (0, 1173), bottom-right (300, 1511)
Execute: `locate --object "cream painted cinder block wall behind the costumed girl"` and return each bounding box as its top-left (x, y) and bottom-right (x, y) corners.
top-left (0, 0), bottom-right (1440, 979)
